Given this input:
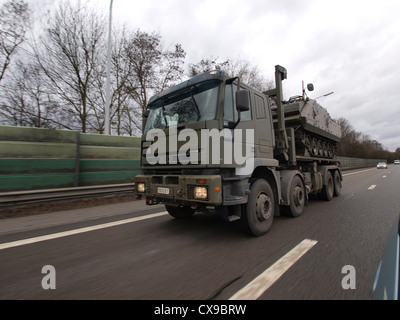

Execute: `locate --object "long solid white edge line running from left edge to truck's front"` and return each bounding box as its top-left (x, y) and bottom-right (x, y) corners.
top-left (0, 211), bottom-right (168, 250)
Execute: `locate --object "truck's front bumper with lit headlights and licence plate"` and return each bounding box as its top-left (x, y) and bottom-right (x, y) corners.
top-left (135, 175), bottom-right (222, 207)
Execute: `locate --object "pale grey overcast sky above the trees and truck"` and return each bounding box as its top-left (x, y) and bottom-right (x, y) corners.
top-left (28, 0), bottom-right (400, 151)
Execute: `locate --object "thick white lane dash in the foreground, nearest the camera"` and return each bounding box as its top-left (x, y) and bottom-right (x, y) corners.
top-left (229, 239), bottom-right (318, 300)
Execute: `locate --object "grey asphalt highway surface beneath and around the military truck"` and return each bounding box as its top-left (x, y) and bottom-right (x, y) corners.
top-left (0, 165), bottom-right (400, 300)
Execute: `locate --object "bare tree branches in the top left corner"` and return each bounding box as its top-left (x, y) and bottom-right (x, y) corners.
top-left (0, 0), bottom-right (30, 82)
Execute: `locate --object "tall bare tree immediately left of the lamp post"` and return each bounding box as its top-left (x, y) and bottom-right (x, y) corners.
top-left (35, 1), bottom-right (105, 132)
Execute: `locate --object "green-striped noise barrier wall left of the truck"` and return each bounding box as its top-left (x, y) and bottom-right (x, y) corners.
top-left (0, 126), bottom-right (140, 192)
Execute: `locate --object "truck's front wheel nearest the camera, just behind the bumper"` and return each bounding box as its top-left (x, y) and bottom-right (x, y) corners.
top-left (242, 179), bottom-right (275, 237)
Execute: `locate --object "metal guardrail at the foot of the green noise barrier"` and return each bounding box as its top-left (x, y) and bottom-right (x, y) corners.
top-left (0, 183), bottom-right (135, 208)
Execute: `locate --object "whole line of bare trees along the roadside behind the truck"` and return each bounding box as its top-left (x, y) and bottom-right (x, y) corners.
top-left (0, 0), bottom-right (400, 158)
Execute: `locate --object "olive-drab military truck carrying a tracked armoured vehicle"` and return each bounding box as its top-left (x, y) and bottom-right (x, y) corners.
top-left (135, 66), bottom-right (342, 236)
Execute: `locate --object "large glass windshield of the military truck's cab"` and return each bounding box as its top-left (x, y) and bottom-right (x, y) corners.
top-left (144, 81), bottom-right (220, 134)
